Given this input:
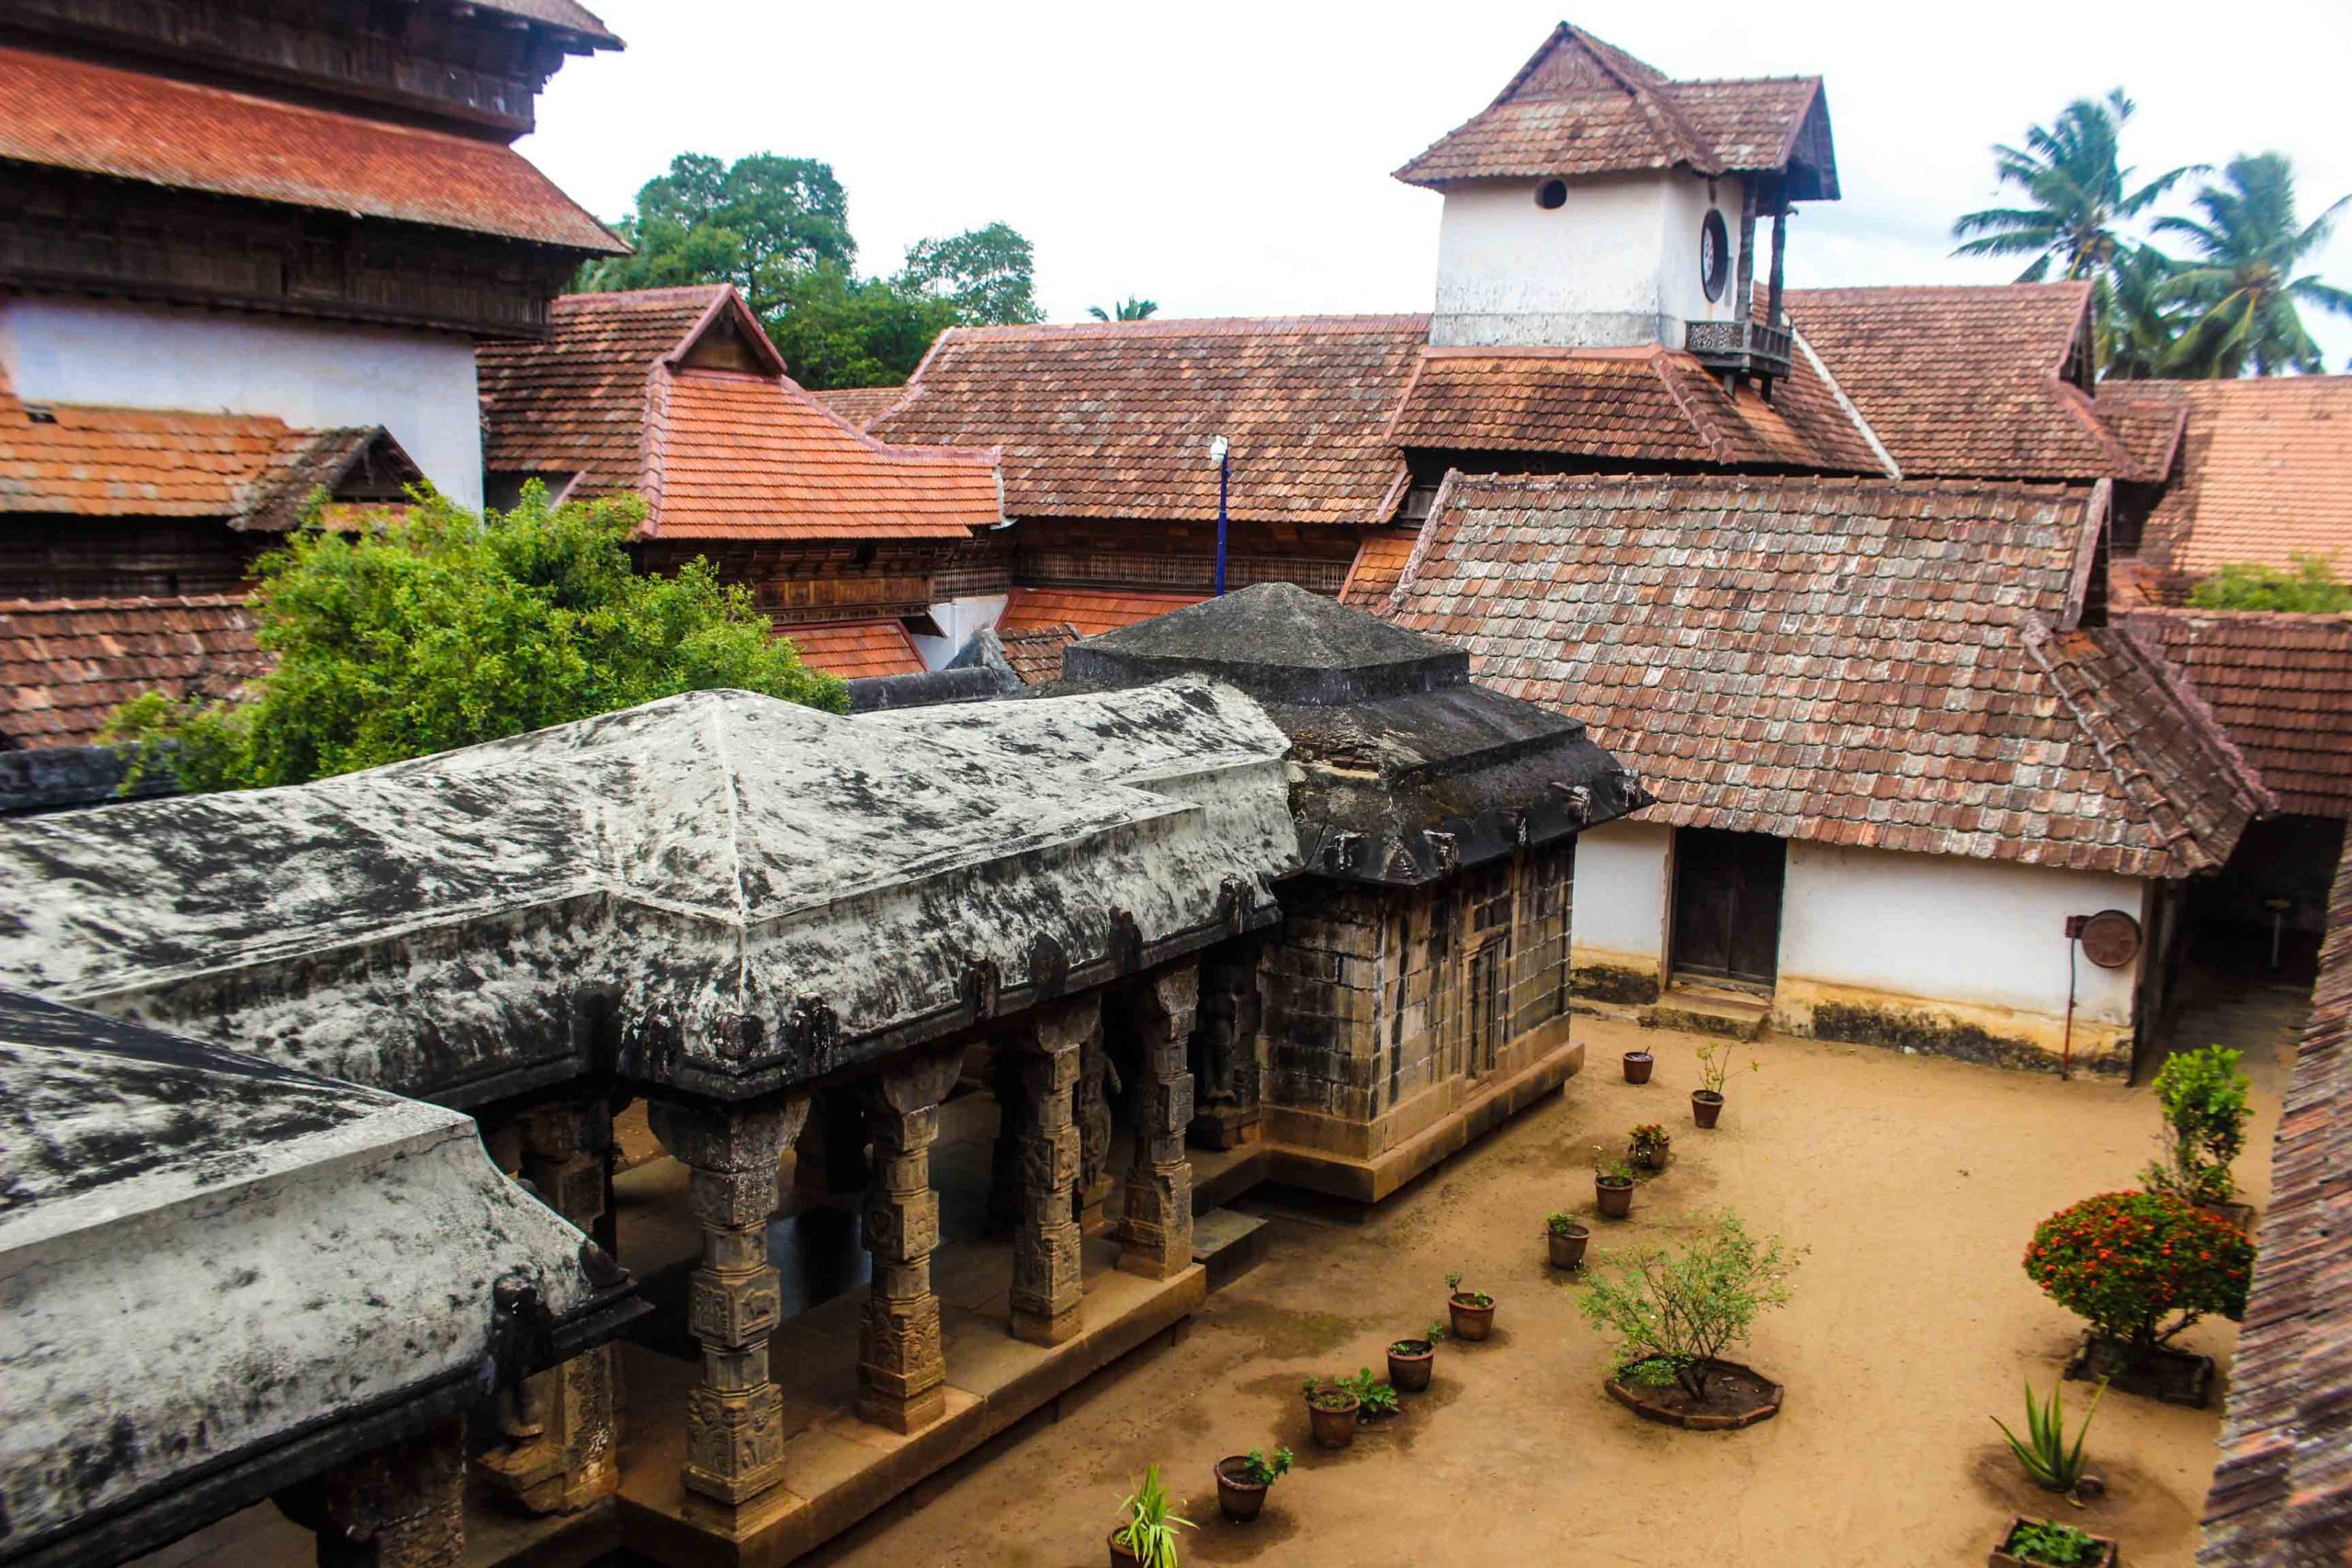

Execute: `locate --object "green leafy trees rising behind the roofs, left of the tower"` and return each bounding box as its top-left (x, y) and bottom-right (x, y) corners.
top-left (579, 152), bottom-right (1045, 390)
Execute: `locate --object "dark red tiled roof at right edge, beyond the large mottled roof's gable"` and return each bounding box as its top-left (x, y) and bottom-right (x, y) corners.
top-left (2121, 609), bottom-right (2352, 818)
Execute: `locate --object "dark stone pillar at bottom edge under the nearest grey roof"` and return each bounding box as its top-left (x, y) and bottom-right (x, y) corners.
top-left (280, 1416), bottom-right (466, 1568)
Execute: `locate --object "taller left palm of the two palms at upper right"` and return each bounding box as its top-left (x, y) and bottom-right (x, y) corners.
top-left (1952, 87), bottom-right (2192, 282)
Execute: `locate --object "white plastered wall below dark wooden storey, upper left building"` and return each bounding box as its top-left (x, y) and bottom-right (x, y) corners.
top-left (0, 296), bottom-right (482, 508)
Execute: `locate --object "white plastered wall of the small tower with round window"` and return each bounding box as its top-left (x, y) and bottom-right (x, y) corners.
top-left (1430, 169), bottom-right (1743, 348)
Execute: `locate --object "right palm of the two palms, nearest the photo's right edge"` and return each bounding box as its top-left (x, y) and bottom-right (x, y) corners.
top-left (2157, 152), bottom-right (2352, 376)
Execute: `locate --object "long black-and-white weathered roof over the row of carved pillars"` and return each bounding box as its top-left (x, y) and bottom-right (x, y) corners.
top-left (0, 689), bottom-right (1289, 1105)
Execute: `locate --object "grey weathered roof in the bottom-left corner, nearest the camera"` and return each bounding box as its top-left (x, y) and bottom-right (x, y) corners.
top-left (0, 989), bottom-right (626, 1561)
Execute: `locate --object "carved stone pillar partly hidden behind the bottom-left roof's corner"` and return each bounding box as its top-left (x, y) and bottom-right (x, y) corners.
top-left (475, 1098), bottom-right (621, 1514)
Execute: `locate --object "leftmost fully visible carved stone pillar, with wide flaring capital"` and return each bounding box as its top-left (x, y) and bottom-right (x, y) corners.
top-left (650, 1098), bottom-right (809, 1505)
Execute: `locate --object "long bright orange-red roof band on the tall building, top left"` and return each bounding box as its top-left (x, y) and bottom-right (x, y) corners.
top-left (0, 50), bottom-right (628, 254)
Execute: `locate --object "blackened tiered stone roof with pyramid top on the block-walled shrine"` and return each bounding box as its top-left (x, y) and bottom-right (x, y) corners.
top-left (1056, 583), bottom-right (1651, 886)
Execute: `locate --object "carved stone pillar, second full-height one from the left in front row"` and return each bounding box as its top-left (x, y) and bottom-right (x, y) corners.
top-left (858, 1048), bottom-right (965, 1432)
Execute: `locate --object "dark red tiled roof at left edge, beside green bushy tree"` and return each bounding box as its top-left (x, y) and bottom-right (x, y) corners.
top-left (0, 594), bottom-right (273, 750)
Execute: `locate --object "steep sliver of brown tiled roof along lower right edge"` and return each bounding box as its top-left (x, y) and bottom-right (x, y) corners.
top-left (2197, 844), bottom-right (2352, 1568)
